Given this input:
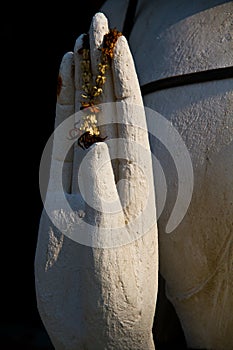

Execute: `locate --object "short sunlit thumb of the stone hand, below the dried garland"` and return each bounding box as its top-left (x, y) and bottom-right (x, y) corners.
top-left (78, 142), bottom-right (124, 247)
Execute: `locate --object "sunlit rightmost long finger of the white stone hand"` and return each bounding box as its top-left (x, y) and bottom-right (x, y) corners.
top-left (112, 36), bottom-right (155, 221)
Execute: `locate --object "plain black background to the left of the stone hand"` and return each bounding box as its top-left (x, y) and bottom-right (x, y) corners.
top-left (0, 0), bottom-right (104, 350)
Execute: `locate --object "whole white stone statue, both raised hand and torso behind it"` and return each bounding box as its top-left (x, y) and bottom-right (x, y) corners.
top-left (35, 0), bottom-right (233, 350)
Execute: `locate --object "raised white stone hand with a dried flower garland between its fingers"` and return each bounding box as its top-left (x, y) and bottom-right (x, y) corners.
top-left (35, 13), bottom-right (158, 350)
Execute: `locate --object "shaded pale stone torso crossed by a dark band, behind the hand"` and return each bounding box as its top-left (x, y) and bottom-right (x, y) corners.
top-left (102, 0), bottom-right (233, 350)
